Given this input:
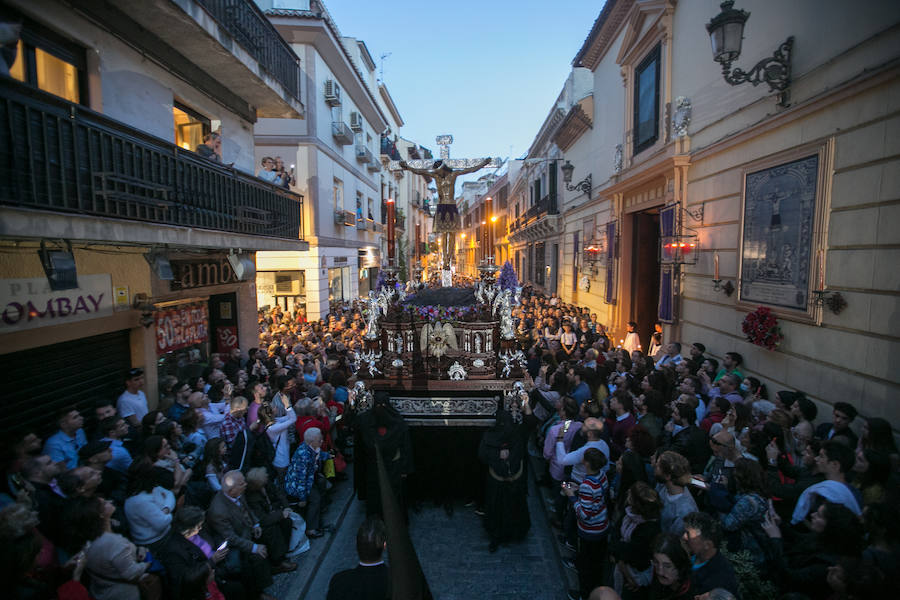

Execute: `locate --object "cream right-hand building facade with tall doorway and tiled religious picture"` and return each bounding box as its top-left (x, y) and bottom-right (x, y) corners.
top-left (506, 0), bottom-right (900, 432)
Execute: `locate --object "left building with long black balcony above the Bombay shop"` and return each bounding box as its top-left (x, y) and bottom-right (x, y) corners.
top-left (0, 0), bottom-right (308, 430)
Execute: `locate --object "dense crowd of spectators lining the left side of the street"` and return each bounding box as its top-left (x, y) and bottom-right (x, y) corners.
top-left (0, 306), bottom-right (364, 600)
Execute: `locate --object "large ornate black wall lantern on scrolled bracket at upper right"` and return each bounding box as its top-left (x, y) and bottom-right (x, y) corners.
top-left (706, 0), bottom-right (794, 106)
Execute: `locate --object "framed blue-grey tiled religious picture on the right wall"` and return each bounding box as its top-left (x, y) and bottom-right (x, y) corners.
top-left (739, 146), bottom-right (825, 318)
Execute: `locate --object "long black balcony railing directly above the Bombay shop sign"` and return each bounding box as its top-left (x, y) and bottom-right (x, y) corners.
top-left (0, 79), bottom-right (303, 240)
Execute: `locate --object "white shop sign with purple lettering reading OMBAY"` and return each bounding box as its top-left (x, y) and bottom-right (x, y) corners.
top-left (0, 273), bottom-right (113, 333)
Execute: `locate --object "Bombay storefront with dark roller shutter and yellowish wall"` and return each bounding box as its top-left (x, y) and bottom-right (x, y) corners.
top-left (0, 248), bottom-right (147, 434)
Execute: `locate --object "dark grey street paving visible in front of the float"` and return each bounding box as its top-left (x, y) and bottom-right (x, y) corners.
top-left (296, 464), bottom-right (567, 600)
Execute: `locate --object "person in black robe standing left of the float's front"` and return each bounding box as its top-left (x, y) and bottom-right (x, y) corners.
top-left (353, 391), bottom-right (413, 517)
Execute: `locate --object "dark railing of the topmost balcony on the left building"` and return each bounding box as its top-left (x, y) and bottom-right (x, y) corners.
top-left (197, 0), bottom-right (300, 100)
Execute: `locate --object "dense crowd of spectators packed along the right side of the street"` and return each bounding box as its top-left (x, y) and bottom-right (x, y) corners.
top-left (514, 291), bottom-right (900, 600)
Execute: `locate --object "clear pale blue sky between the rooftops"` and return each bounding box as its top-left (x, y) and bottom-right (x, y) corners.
top-left (324, 0), bottom-right (603, 180)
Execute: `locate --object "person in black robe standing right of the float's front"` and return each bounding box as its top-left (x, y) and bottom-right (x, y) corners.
top-left (478, 403), bottom-right (534, 552)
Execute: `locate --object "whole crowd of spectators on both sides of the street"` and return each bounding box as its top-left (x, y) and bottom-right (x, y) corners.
top-left (0, 290), bottom-right (900, 600)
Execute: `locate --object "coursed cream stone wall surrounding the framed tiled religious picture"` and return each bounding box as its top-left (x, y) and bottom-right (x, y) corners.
top-left (681, 78), bottom-right (900, 424)
